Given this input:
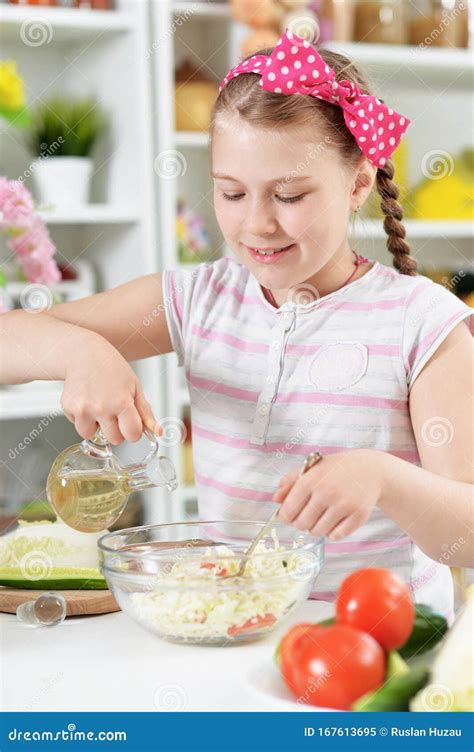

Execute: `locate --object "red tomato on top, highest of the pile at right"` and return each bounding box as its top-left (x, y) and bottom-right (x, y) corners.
top-left (336, 567), bottom-right (415, 651)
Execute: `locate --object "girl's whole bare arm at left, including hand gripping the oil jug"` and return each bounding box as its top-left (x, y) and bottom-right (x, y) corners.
top-left (0, 274), bottom-right (173, 444)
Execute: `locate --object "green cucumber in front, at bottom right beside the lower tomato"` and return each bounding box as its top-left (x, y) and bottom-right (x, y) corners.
top-left (352, 666), bottom-right (429, 713)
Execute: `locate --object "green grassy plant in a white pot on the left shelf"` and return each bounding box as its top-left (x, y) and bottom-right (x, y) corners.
top-left (28, 96), bottom-right (105, 208)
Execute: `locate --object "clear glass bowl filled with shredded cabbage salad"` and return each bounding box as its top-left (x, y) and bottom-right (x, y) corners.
top-left (99, 521), bottom-right (324, 645)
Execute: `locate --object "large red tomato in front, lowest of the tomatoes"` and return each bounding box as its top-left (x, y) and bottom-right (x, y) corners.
top-left (296, 624), bottom-right (385, 710)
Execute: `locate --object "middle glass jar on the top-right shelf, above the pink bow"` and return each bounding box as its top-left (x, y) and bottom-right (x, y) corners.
top-left (354, 0), bottom-right (408, 44)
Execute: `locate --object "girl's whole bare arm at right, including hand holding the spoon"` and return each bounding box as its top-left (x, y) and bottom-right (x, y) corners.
top-left (273, 323), bottom-right (474, 567)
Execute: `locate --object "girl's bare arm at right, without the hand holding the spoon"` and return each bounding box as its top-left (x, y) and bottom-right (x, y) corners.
top-left (378, 323), bottom-right (474, 566)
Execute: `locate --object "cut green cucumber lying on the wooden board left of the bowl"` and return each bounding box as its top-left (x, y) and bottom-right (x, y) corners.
top-left (0, 567), bottom-right (107, 590)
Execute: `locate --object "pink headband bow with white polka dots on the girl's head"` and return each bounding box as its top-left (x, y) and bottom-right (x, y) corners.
top-left (219, 29), bottom-right (410, 167)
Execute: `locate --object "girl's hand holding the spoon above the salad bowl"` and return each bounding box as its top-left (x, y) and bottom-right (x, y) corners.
top-left (273, 449), bottom-right (385, 540)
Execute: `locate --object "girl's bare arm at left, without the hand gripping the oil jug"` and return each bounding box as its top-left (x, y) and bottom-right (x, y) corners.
top-left (0, 274), bottom-right (173, 384)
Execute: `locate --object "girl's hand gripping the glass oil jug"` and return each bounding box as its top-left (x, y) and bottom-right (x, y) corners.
top-left (61, 332), bottom-right (162, 444)
